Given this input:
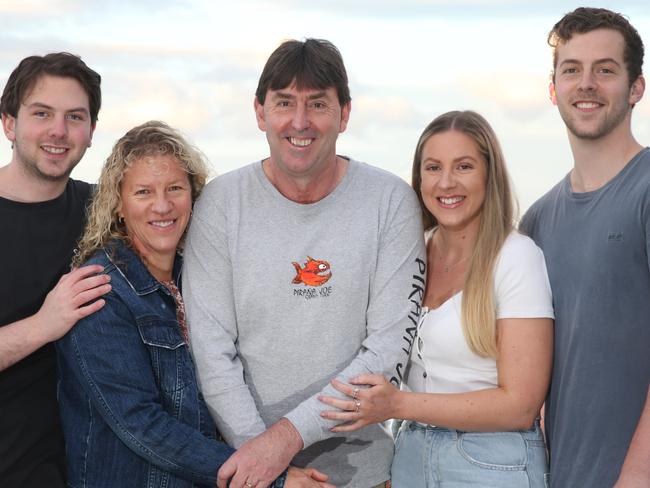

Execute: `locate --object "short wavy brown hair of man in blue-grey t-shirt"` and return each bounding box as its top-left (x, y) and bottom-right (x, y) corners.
top-left (548, 7), bottom-right (644, 86)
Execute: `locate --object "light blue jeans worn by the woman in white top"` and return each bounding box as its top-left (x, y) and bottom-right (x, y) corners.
top-left (391, 422), bottom-right (548, 488)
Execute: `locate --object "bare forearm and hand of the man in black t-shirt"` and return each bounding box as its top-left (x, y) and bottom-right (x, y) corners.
top-left (0, 265), bottom-right (111, 371)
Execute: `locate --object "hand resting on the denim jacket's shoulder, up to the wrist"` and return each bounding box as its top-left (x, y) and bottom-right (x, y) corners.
top-left (34, 264), bottom-right (111, 344)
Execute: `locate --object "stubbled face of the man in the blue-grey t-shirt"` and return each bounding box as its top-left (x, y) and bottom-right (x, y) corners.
top-left (551, 29), bottom-right (644, 140)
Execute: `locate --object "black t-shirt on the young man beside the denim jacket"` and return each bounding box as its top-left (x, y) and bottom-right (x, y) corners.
top-left (0, 180), bottom-right (91, 488)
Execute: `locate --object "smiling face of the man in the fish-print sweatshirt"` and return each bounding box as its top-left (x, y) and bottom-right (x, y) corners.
top-left (255, 83), bottom-right (350, 179)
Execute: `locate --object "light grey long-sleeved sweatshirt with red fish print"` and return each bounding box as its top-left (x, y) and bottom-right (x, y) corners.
top-left (183, 160), bottom-right (426, 488)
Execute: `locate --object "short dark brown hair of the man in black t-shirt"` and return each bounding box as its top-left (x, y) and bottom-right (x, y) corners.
top-left (0, 52), bottom-right (102, 124)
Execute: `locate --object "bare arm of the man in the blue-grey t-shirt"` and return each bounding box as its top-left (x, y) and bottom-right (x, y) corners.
top-left (614, 388), bottom-right (650, 488)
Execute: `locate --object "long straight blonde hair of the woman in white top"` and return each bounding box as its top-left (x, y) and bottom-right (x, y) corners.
top-left (412, 110), bottom-right (517, 358)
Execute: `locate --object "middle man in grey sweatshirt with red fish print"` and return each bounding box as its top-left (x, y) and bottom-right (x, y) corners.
top-left (183, 39), bottom-right (425, 488)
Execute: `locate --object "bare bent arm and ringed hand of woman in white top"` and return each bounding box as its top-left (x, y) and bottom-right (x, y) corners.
top-left (322, 318), bottom-right (553, 432)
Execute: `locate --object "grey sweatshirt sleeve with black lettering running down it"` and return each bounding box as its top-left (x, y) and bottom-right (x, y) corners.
top-left (285, 185), bottom-right (426, 447)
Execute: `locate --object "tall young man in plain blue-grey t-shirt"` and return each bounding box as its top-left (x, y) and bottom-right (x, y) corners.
top-left (522, 8), bottom-right (650, 488)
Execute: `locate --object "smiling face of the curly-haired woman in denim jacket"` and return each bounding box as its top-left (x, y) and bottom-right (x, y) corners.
top-left (118, 154), bottom-right (192, 263)
